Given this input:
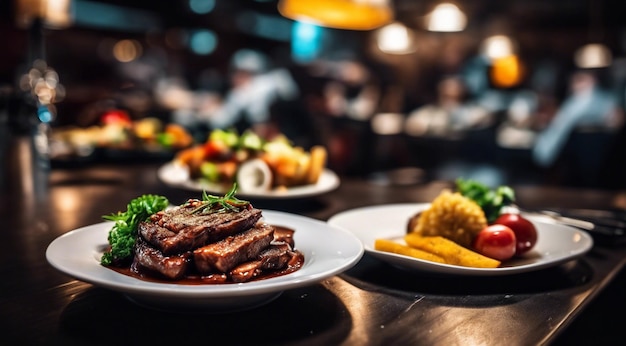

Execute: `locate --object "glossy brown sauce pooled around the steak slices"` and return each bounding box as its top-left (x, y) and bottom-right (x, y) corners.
top-left (107, 225), bottom-right (304, 285)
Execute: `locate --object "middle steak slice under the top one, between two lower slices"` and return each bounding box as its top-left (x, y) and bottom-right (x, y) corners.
top-left (193, 223), bottom-right (274, 273)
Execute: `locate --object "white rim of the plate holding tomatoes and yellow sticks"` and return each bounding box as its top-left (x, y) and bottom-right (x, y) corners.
top-left (327, 203), bottom-right (594, 276)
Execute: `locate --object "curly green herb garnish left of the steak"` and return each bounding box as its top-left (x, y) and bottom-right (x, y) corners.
top-left (100, 195), bottom-right (169, 266)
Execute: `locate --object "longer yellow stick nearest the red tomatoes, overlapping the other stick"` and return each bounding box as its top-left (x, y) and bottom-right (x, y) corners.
top-left (404, 233), bottom-right (500, 268)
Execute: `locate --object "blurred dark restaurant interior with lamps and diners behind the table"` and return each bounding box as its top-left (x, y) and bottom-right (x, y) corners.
top-left (0, 0), bottom-right (626, 189)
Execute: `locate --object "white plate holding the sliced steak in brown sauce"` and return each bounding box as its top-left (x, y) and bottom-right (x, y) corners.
top-left (46, 210), bottom-right (363, 313)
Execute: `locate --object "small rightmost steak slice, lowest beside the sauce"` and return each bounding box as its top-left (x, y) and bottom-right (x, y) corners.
top-left (230, 243), bottom-right (295, 282)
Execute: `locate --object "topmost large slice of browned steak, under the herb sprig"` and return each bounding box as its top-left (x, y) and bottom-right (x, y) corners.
top-left (138, 200), bottom-right (262, 255)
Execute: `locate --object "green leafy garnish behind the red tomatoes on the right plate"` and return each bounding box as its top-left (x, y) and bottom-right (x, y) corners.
top-left (456, 178), bottom-right (515, 222)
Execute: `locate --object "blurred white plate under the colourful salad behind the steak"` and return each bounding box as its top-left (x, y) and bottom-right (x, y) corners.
top-left (157, 162), bottom-right (340, 199)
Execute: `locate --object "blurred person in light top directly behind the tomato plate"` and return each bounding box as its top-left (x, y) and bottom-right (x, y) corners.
top-left (405, 74), bottom-right (504, 184)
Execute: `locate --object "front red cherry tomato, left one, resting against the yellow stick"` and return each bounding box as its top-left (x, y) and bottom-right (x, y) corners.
top-left (472, 224), bottom-right (517, 261)
